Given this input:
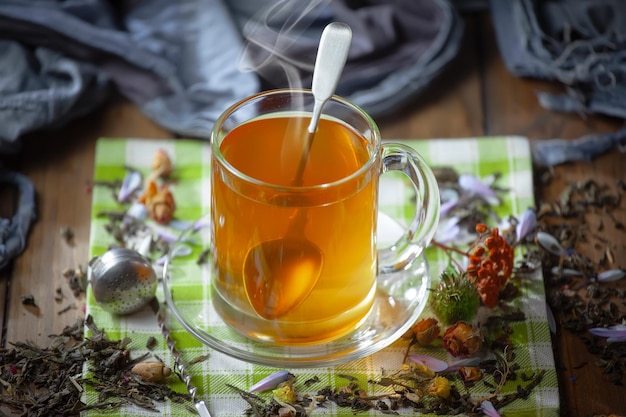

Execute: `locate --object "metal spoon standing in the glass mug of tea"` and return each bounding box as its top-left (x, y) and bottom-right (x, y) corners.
top-left (243, 22), bottom-right (352, 320)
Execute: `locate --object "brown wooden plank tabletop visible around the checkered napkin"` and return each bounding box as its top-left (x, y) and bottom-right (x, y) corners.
top-left (0, 14), bottom-right (626, 417)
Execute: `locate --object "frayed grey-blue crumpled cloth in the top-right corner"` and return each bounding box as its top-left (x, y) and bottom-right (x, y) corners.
top-left (490, 0), bottom-right (626, 166)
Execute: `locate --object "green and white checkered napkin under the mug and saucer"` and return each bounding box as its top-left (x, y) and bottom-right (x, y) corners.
top-left (84, 137), bottom-right (559, 417)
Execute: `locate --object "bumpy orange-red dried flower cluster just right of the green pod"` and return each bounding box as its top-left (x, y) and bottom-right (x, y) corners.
top-left (466, 224), bottom-right (515, 308)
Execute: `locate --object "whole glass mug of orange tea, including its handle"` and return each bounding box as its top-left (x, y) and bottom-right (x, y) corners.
top-left (210, 89), bottom-right (439, 345)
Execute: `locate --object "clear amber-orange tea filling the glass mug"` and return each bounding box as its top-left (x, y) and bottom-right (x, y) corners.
top-left (211, 113), bottom-right (380, 344)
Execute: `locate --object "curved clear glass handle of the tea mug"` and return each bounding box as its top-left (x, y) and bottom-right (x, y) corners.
top-left (378, 143), bottom-right (440, 274)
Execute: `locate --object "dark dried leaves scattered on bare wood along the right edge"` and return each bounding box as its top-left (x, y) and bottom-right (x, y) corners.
top-left (528, 179), bottom-right (626, 385)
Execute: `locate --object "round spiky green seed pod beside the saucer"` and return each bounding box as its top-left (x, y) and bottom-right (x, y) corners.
top-left (430, 270), bottom-right (480, 325)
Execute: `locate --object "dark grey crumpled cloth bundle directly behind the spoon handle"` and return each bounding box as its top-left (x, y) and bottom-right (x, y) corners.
top-left (229, 0), bottom-right (463, 118)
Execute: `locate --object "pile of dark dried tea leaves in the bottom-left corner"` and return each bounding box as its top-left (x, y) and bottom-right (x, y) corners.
top-left (0, 316), bottom-right (189, 417)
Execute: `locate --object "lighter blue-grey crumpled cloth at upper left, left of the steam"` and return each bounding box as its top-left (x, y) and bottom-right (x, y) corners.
top-left (0, 0), bottom-right (258, 153)
